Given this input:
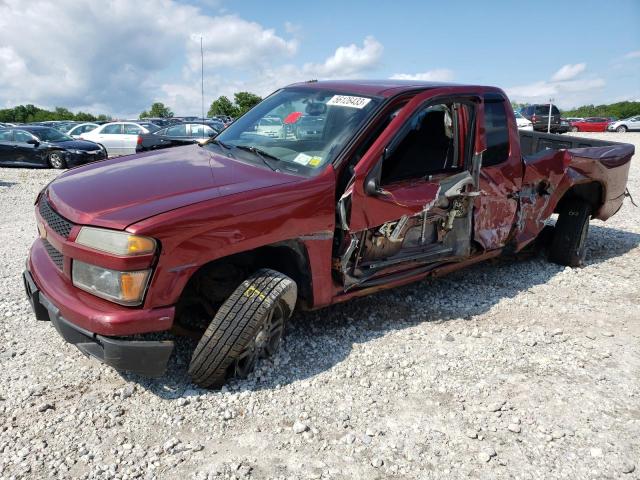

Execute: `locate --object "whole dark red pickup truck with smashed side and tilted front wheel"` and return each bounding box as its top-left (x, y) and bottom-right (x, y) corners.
top-left (24, 81), bottom-right (634, 387)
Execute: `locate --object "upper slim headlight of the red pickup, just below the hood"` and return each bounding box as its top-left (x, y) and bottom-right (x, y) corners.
top-left (76, 227), bottom-right (156, 256)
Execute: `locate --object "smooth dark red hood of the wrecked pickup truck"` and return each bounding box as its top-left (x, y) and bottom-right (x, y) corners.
top-left (47, 145), bottom-right (301, 229)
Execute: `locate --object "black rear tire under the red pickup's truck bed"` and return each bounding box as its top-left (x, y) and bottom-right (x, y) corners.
top-left (549, 200), bottom-right (591, 267)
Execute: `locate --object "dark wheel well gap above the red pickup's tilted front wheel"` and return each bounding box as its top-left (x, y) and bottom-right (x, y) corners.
top-left (177, 240), bottom-right (313, 326)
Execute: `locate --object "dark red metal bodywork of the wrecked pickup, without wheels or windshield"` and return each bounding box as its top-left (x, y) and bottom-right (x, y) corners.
top-left (28, 82), bottom-right (633, 342)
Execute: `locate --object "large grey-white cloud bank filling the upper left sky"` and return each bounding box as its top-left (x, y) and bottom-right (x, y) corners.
top-left (0, 0), bottom-right (297, 114)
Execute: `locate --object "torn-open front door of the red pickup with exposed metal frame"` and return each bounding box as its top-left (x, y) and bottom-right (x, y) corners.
top-left (334, 89), bottom-right (485, 292)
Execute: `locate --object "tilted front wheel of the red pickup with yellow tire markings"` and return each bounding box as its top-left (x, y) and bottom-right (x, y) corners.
top-left (189, 269), bottom-right (297, 388)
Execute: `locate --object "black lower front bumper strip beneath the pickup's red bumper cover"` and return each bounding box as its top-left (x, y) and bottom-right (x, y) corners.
top-left (22, 270), bottom-right (173, 377)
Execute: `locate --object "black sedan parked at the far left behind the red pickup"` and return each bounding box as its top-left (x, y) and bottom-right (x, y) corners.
top-left (0, 125), bottom-right (107, 168)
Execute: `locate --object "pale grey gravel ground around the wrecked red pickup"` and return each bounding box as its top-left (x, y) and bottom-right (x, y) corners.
top-left (0, 133), bottom-right (640, 479)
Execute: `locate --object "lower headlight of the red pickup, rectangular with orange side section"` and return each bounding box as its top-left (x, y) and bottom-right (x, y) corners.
top-left (72, 260), bottom-right (151, 306)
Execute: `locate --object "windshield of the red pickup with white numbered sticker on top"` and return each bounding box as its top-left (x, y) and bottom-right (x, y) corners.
top-left (205, 88), bottom-right (380, 175)
